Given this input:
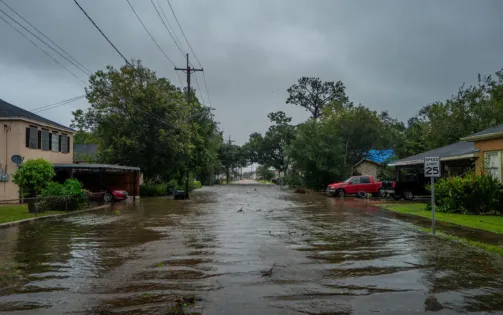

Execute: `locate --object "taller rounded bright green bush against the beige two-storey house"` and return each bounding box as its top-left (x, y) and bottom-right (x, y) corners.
top-left (12, 159), bottom-right (56, 196)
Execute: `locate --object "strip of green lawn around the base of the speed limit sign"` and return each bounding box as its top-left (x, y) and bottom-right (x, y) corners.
top-left (381, 203), bottom-right (503, 234)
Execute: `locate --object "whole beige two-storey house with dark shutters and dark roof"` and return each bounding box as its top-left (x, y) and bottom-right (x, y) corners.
top-left (0, 99), bottom-right (74, 201)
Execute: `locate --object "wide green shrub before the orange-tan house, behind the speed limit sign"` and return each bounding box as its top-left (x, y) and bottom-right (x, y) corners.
top-left (435, 172), bottom-right (503, 214)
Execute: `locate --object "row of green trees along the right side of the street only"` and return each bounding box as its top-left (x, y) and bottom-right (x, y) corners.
top-left (241, 70), bottom-right (503, 189)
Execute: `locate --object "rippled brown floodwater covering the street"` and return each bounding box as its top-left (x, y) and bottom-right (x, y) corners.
top-left (0, 185), bottom-right (503, 314)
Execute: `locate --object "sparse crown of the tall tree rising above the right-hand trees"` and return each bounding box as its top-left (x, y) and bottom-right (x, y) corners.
top-left (286, 77), bottom-right (351, 119)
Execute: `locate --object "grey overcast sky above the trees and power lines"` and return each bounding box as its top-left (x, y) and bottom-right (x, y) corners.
top-left (0, 0), bottom-right (503, 144)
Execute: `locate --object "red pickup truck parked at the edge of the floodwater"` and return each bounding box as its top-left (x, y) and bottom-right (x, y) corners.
top-left (327, 175), bottom-right (391, 197)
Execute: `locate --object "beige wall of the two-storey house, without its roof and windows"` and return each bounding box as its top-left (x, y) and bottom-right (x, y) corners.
top-left (0, 120), bottom-right (73, 200)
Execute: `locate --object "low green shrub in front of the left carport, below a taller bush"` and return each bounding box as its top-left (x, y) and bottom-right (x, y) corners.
top-left (40, 179), bottom-right (88, 210)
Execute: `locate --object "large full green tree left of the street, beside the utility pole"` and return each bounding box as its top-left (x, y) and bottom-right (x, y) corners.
top-left (74, 61), bottom-right (221, 182)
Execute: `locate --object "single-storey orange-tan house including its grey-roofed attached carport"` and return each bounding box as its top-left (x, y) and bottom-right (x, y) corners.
top-left (389, 124), bottom-right (503, 182)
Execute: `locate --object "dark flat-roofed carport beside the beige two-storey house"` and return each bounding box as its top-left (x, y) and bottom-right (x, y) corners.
top-left (54, 164), bottom-right (141, 199)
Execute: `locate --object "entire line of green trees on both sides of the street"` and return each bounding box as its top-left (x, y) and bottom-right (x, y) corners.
top-left (72, 61), bottom-right (503, 189)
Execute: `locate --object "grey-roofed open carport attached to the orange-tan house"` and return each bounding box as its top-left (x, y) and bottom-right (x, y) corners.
top-left (388, 141), bottom-right (479, 181)
